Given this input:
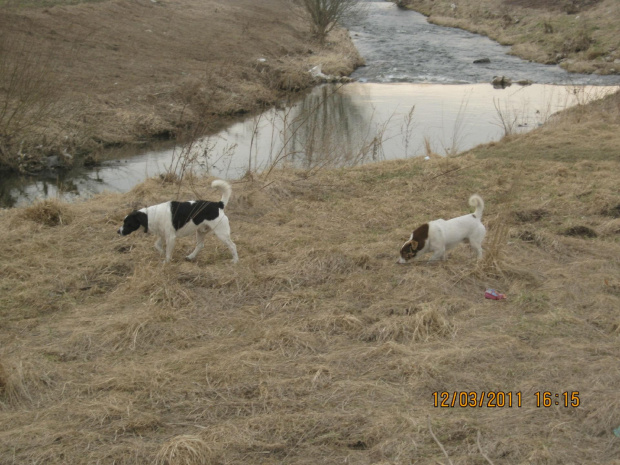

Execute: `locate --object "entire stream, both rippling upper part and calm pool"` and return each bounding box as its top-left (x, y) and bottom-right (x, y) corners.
top-left (0, 0), bottom-right (620, 207)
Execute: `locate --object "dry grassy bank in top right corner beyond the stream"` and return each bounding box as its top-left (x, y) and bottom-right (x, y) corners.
top-left (392, 0), bottom-right (620, 74)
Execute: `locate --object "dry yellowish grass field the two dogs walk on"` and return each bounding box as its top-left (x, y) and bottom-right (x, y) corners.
top-left (0, 85), bottom-right (620, 465)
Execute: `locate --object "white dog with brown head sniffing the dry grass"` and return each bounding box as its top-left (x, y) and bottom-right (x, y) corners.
top-left (398, 195), bottom-right (486, 263)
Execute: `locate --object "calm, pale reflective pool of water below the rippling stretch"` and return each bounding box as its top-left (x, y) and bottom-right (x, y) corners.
top-left (0, 83), bottom-right (619, 207)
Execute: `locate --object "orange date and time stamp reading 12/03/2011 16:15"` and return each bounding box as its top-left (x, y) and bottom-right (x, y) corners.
top-left (433, 391), bottom-right (581, 408)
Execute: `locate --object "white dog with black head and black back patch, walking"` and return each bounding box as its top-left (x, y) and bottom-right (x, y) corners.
top-left (118, 180), bottom-right (239, 263)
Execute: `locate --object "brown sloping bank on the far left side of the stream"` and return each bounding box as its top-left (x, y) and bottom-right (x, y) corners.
top-left (0, 0), bottom-right (361, 172)
